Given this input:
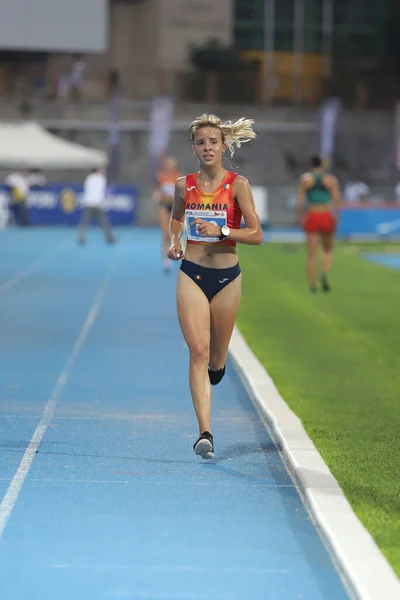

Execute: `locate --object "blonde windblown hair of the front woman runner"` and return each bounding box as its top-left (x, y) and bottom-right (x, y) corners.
top-left (189, 113), bottom-right (256, 157)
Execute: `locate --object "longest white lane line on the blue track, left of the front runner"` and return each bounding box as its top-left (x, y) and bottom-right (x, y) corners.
top-left (0, 255), bottom-right (116, 541)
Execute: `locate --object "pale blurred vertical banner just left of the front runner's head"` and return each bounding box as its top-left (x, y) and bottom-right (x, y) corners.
top-left (149, 95), bottom-right (173, 158)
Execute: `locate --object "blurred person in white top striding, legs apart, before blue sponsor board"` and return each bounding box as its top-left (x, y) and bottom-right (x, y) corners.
top-left (78, 167), bottom-right (115, 245)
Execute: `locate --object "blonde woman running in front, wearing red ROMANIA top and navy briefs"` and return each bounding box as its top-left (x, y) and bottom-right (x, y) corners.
top-left (168, 114), bottom-right (263, 459)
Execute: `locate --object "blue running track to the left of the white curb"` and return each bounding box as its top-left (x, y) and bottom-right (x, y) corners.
top-left (0, 229), bottom-right (348, 600)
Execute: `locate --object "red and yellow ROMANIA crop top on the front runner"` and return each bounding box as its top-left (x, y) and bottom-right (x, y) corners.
top-left (185, 171), bottom-right (242, 247)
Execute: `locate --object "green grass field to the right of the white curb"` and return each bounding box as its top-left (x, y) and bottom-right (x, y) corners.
top-left (238, 245), bottom-right (400, 575)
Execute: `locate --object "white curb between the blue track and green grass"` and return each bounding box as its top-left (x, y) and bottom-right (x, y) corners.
top-left (229, 328), bottom-right (400, 600)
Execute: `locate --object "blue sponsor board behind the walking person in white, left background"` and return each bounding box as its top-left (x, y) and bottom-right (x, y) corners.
top-left (0, 184), bottom-right (138, 225)
